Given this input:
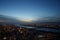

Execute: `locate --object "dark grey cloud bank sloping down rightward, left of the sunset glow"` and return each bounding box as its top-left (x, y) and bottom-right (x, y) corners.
top-left (0, 15), bottom-right (32, 24)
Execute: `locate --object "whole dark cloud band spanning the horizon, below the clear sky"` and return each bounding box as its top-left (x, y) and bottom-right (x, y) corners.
top-left (0, 15), bottom-right (60, 24)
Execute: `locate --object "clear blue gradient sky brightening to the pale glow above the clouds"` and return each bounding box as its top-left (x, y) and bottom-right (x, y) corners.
top-left (0, 0), bottom-right (60, 20)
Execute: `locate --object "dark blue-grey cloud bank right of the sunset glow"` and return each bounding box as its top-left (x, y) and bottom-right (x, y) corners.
top-left (33, 17), bottom-right (60, 24)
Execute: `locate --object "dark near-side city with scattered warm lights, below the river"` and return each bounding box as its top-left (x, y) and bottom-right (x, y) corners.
top-left (0, 24), bottom-right (60, 40)
